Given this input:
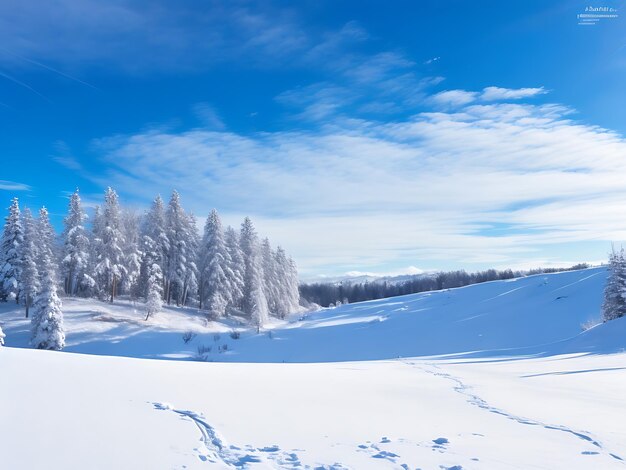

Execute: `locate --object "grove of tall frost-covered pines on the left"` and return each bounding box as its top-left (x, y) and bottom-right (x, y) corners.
top-left (0, 188), bottom-right (300, 349)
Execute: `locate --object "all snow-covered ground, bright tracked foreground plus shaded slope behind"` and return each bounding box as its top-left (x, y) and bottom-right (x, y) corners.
top-left (0, 268), bottom-right (626, 469)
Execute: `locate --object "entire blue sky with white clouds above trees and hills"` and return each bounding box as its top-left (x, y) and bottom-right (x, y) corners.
top-left (0, 0), bottom-right (626, 278)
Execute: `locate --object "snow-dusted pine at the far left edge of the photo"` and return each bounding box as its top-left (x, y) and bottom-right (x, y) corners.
top-left (0, 198), bottom-right (24, 302)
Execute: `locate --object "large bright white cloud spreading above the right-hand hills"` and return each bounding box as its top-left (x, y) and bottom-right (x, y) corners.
top-left (89, 99), bottom-right (626, 274)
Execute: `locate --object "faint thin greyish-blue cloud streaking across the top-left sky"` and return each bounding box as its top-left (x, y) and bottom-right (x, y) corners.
top-left (0, 0), bottom-right (312, 72)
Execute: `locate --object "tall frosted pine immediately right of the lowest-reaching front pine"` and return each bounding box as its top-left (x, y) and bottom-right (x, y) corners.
top-left (61, 189), bottom-right (93, 296)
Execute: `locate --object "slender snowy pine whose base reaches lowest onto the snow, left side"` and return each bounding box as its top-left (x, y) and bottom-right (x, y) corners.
top-left (31, 207), bottom-right (65, 351)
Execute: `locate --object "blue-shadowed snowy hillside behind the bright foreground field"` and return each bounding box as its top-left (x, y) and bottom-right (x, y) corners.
top-left (0, 268), bottom-right (625, 362)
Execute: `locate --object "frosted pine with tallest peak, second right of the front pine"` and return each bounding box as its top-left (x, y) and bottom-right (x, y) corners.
top-left (94, 187), bottom-right (125, 302)
